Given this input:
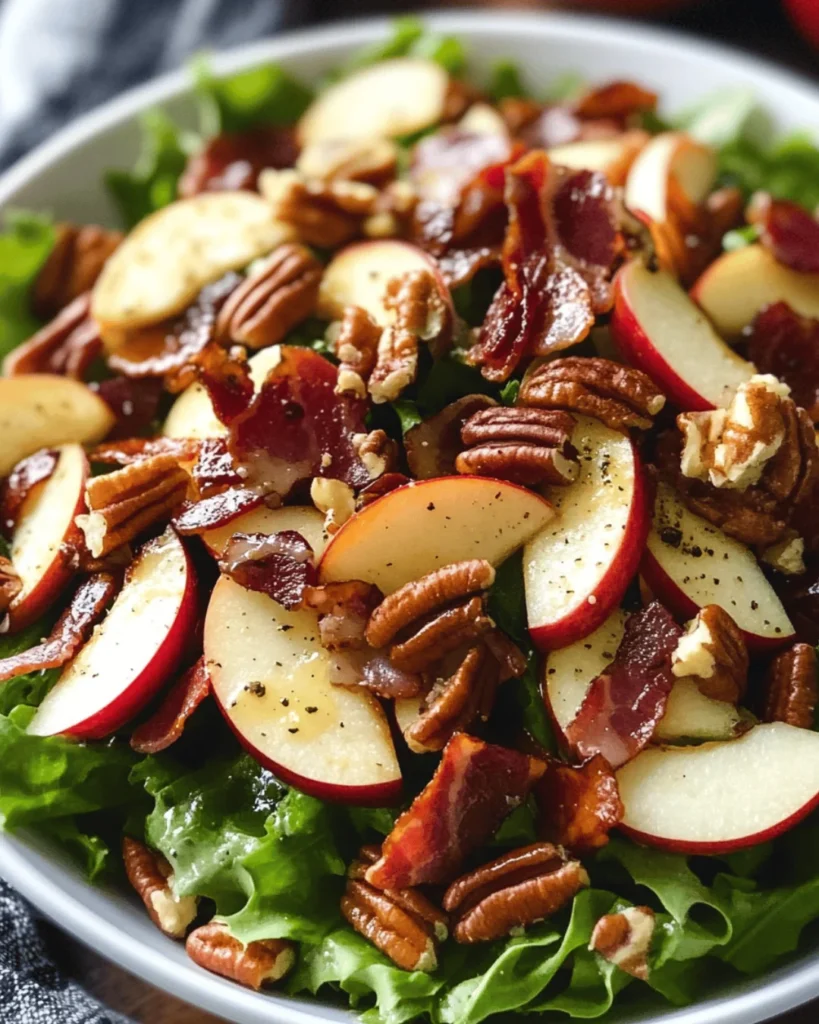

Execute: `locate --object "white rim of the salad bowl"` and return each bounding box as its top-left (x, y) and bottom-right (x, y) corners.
top-left (0, 9), bottom-right (819, 1024)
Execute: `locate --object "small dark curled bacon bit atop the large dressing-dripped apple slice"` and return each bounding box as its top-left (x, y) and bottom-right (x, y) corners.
top-left (219, 529), bottom-right (316, 610)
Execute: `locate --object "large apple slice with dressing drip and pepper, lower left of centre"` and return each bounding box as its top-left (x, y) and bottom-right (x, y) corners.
top-left (205, 577), bottom-right (401, 804)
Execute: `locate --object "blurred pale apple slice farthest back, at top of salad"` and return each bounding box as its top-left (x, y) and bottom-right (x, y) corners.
top-left (297, 57), bottom-right (449, 146)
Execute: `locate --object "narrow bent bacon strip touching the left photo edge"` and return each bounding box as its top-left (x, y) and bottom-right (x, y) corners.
top-left (0, 572), bottom-right (121, 683)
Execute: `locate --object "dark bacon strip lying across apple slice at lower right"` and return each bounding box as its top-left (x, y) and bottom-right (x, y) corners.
top-left (566, 601), bottom-right (683, 768)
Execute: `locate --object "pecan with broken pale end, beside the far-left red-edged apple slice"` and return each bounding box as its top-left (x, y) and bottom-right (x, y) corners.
top-left (75, 455), bottom-right (189, 558)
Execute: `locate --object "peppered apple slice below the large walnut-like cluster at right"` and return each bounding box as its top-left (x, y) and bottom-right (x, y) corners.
top-left (641, 483), bottom-right (794, 650)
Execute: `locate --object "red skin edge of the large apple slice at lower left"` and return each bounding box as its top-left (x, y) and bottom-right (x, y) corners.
top-left (63, 542), bottom-right (200, 739)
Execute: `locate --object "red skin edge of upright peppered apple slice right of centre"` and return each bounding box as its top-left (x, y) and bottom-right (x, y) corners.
top-left (529, 443), bottom-right (651, 653)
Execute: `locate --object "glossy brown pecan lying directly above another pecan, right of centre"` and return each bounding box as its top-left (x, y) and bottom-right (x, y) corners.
top-left (518, 355), bottom-right (665, 431)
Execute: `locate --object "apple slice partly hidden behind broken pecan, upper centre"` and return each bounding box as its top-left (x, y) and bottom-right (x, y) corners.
top-left (318, 239), bottom-right (452, 327)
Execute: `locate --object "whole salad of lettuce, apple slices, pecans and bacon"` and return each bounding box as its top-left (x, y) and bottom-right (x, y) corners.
top-left (0, 19), bottom-right (819, 1024)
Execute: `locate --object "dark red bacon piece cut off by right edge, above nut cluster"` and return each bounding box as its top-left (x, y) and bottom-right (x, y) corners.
top-left (747, 302), bottom-right (819, 423)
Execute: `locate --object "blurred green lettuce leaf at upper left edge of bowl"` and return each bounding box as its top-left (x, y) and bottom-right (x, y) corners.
top-left (0, 211), bottom-right (55, 359)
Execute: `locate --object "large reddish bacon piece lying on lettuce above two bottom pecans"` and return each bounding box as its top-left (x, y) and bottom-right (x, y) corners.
top-left (367, 732), bottom-right (546, 889)
